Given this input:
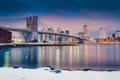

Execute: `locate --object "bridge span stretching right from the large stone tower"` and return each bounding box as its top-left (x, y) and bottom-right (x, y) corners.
top-left (38, 32), bottom-right (85, 44)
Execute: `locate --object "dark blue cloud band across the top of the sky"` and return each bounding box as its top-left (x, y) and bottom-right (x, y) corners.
top-left (0, 0), bottom-right (120, 15)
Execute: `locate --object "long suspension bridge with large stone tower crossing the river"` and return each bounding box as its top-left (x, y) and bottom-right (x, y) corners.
top-left (0, 16), bottom-right (87, 44)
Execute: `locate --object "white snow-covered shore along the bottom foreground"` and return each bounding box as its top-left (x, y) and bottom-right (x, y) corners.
top-left (0, 67), bottom-right (120, 80)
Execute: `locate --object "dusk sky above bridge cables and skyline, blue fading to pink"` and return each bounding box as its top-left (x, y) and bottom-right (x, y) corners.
top-left (0, 0), bottom-right (120, 37)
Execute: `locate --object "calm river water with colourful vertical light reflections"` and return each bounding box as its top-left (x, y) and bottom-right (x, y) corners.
top-left (0, 44), bottom-right (120, 70)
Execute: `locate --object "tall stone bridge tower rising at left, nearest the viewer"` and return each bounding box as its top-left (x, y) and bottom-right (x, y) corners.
top-left (26, 16), bottom-right (38, 42)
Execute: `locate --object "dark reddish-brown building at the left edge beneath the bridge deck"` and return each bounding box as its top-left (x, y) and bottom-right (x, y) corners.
top-left (0, 28), bottom-right (12, 43)
